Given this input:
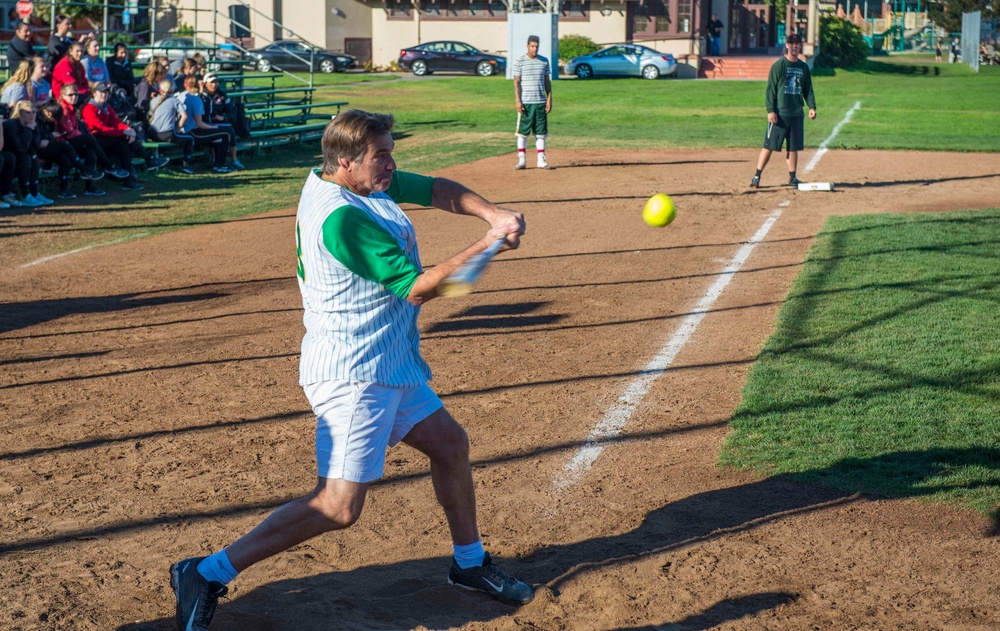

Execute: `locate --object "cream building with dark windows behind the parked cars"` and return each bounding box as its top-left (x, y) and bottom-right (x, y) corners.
top-left (161, 0), bottom-right (818, 77)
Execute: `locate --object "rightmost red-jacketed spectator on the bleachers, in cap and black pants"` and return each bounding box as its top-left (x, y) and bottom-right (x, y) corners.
top-left (83, 83), bottom-right (169, 191)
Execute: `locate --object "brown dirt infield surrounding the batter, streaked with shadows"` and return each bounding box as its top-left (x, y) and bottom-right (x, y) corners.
top-left (0, 151), bottom-right (1000, 631)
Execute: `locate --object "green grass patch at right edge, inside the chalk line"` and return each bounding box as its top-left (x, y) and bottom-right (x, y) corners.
top-left (721, 210), bottom-right (1000, 517)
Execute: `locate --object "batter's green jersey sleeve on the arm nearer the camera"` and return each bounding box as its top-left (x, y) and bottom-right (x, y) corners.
top-left (323, 206), bottom-right (421, 300)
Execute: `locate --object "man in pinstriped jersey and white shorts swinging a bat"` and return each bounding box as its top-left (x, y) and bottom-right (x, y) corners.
top-left (170, 110), bottom-right (534, 631)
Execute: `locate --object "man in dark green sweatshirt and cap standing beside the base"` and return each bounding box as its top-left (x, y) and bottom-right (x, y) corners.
top-left (750, 33), bottom-right (816, 188)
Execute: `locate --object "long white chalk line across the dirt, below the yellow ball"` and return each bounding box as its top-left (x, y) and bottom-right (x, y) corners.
top-left (554, 201), bottom-right (789, 491)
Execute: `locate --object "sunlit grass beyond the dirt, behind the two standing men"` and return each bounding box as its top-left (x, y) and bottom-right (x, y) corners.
top-left (318, 59), bottom-right (1000, 166)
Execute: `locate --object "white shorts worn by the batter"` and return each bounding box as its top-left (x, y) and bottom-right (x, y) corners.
top-left (303, 380), bottom-right (444, 482)
